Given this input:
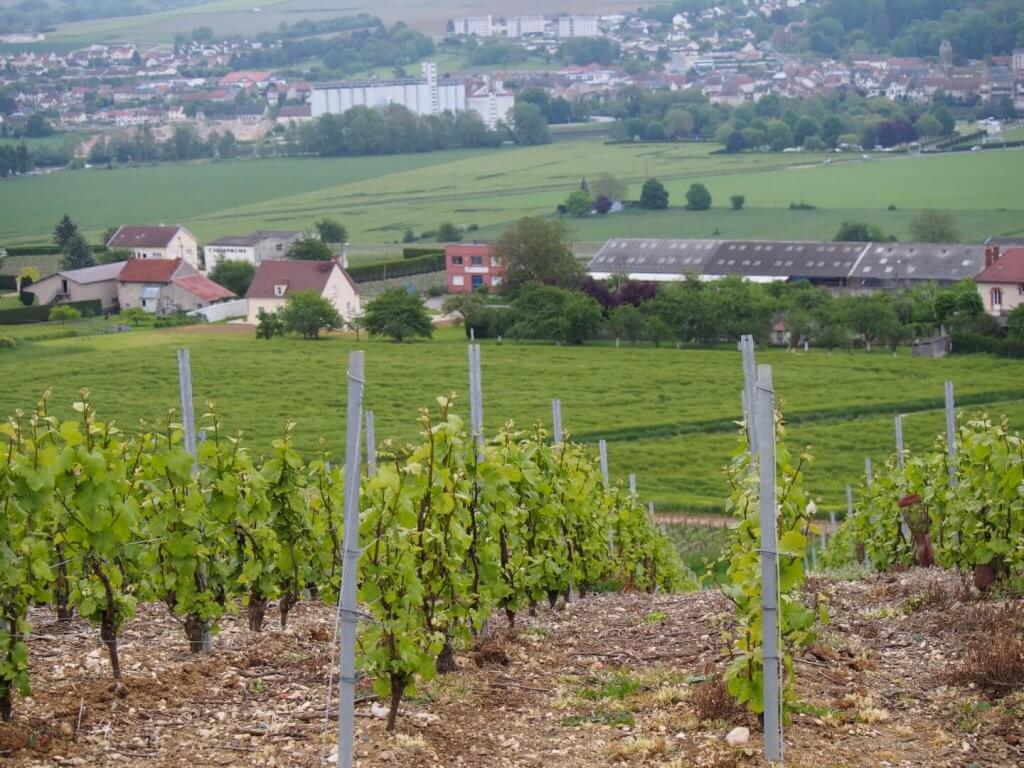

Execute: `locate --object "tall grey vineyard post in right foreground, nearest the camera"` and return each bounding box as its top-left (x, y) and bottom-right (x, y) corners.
top-left (748, 364), bottom-right (782, 762)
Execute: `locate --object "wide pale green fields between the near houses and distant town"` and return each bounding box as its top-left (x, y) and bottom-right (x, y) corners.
top-left (0, 140), bottom-right (1024, 244)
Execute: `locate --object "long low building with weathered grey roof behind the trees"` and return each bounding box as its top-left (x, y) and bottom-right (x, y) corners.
top-left (587, 239), bottom-right (985, 289)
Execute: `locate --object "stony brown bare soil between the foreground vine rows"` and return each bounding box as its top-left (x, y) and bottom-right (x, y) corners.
top-left (0, 570), bottom-right (1024, 768)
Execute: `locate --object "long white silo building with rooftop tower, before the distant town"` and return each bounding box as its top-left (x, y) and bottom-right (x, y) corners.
top-left (311, 62), bottom-right (466, 118)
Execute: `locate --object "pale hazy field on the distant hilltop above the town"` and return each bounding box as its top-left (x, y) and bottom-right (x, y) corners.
top-left (36, 0), bottom-right (636, 45)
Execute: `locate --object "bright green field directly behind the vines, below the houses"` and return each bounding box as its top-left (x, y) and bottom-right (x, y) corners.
top-left (0, 327), bottom-right (1024, 511)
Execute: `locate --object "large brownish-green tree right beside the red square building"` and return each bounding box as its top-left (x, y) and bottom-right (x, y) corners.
top-left (498, 217), bottom-right (583, 293)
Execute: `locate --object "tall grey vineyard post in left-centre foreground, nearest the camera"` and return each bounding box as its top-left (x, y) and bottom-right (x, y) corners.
top-left (338, 352), bottom-right (365, 768)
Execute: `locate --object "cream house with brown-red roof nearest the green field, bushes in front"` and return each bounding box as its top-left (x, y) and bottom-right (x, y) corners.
top-left (246, 259), bottom-right (361, 325)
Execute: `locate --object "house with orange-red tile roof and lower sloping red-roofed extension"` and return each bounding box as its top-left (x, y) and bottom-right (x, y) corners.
top-left (118, 259), bottom-right (237, 315)
